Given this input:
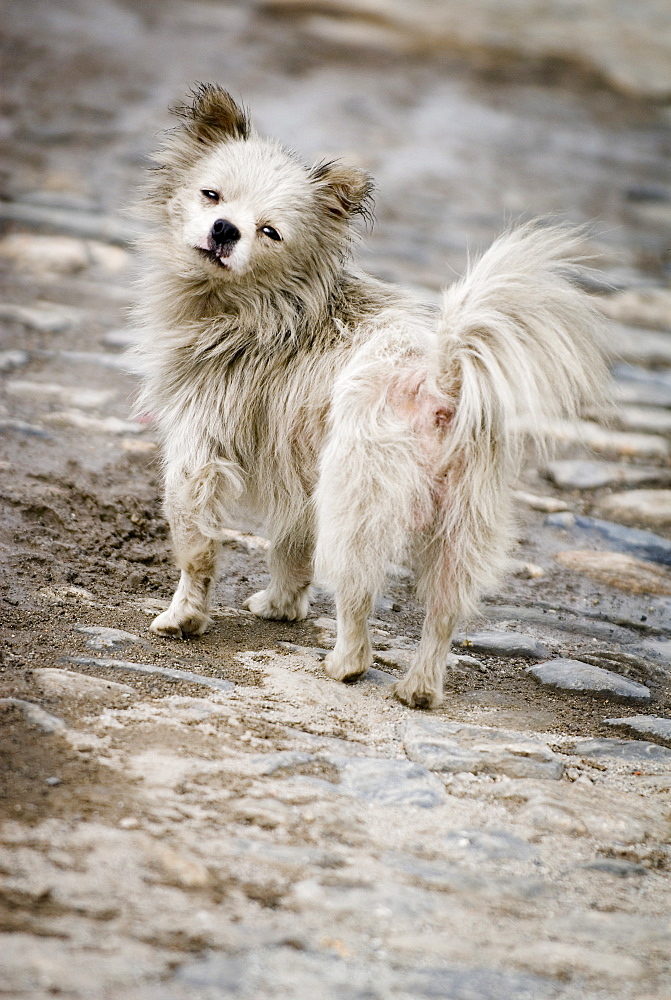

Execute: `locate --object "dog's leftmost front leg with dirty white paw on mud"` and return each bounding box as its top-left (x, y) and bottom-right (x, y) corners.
top-left (150, 480), bottom-right (222, 639)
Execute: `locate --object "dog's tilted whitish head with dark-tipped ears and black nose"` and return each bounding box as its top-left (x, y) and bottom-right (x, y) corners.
top-left (148, 85), bottom-right (372, 284)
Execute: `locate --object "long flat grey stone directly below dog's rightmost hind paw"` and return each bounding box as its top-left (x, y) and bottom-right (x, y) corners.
top-left (403, 719), bottom-right (564, 779)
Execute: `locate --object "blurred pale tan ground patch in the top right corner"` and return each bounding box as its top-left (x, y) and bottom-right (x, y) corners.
top-left (263, 0), bottom-right (671, 100)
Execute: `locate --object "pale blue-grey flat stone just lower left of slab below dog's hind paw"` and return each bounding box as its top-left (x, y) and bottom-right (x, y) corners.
top-left (324, 754), bottom-right (446, 809)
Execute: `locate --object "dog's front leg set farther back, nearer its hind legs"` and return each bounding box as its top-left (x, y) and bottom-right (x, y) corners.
top-left (243, 537), bottom-right (312, 622)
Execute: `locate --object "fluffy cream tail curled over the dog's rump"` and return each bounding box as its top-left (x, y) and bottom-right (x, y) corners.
top-left (439, 223), bottom-right (607, 465)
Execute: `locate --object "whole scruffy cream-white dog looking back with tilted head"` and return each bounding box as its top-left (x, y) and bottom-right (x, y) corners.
top-left (139, 85), bottom-right (605, 707)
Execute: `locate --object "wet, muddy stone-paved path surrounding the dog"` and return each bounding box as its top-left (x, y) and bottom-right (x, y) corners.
top-left (0, 2), bottom-right (671, 1000)
